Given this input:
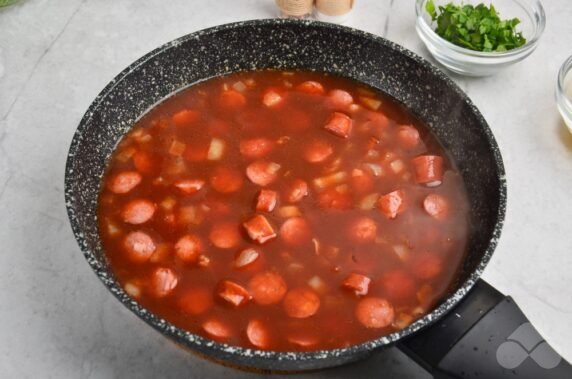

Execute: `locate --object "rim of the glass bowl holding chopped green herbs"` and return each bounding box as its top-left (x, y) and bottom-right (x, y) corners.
top-left (415, 0), bottom-right (546, 60)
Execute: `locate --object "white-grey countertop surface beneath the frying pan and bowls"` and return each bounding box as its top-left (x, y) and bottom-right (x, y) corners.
top-left (0, 0), bottom-right (572, 378)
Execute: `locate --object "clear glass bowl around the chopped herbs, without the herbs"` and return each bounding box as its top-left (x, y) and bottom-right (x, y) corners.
top-left (415, 0), bottom-right (546, 76)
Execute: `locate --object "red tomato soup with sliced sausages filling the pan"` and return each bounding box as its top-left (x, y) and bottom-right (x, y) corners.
top-left (98, 71), bottom-right (469, 351)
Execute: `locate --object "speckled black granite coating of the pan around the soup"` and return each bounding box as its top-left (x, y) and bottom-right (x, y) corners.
top-left (65, 20), bottom-right (506, 370)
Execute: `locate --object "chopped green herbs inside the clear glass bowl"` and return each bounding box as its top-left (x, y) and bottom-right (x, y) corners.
top-left (425, 0), bottom-right (526, 52)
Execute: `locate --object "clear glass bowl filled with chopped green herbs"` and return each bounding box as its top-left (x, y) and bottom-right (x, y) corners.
top-left (415, 0), bottom-right (546, 76)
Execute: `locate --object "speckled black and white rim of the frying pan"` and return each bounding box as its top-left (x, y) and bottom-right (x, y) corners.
top-left (65, 19), bottom-right (507, 368)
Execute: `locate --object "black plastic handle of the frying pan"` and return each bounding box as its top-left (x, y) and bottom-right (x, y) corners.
top-left (398, 280), bottom-right (572, 379)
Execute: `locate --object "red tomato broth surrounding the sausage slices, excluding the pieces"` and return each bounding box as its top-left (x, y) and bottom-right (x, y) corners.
top-left (98, 71), bottom-right (470, 351)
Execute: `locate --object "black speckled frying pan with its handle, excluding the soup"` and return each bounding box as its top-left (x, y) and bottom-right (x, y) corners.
top-left (65, 20), bottom-right (572, 379)
